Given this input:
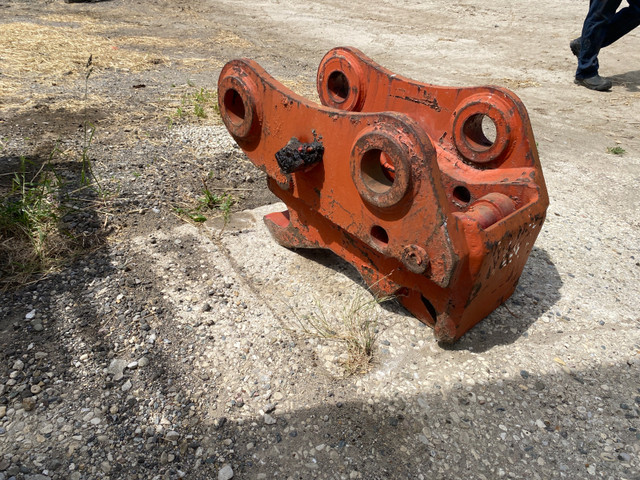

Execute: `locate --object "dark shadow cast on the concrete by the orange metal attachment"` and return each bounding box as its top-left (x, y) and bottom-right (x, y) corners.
top-left (295, 247), bottom-right (562, 352)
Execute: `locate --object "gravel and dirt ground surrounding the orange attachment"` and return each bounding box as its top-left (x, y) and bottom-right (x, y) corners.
top-left (0, 0), bottom-right (640, 480)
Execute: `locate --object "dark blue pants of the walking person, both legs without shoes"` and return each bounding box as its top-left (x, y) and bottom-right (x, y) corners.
top-left (576, 0), bottom-right (640, 78)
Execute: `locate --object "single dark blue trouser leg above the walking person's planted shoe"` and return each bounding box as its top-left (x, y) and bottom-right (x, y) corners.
top-left (576, 0), bottom-right (622, 80)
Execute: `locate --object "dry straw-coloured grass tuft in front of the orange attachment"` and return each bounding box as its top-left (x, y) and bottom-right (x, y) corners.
top-left (296, 292), bottom-right (391, 375)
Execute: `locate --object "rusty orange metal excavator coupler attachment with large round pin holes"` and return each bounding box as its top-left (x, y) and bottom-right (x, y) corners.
top-left (218, 48), bottom-right (548, 343)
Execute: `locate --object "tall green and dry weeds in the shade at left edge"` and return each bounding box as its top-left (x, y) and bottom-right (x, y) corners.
top-left (0, 56), bottom-right (105, 288)
